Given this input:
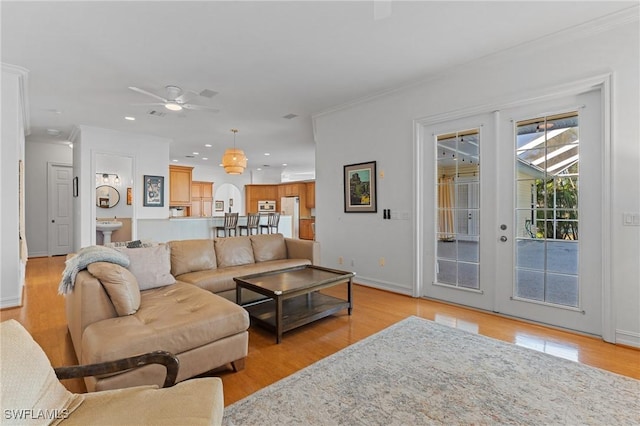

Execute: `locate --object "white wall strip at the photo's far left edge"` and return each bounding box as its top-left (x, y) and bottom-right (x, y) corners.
top-left (0, 64), bottom-right (29, 308)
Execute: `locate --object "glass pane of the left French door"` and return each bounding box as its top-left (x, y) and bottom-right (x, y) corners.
top-left (435, 129), bottom-right (480, 289)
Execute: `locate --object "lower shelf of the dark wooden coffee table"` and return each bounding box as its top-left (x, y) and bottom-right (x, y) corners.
top-left (245, 291), bottom-right (349, 338)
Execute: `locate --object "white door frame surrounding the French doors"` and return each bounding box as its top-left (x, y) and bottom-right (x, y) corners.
top-left (413, 73), bottom-right (615, 343)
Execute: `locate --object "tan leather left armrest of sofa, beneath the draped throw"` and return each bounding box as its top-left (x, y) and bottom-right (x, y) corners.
top-left (64, 270), bottom-right (118, 360)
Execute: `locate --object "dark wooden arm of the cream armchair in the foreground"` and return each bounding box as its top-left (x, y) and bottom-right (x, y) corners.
top-left (54, 351), bottom-right (180, 388)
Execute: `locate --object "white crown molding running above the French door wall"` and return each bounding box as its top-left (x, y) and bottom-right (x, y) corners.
top-left (311, 2), bottom-right (640, 120)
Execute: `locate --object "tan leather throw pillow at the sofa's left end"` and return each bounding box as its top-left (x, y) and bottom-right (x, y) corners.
top-left (87, 262), bottom-right (140, 316)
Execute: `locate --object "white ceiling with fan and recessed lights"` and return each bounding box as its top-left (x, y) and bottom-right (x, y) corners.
top-left (0, 1), bottom-right (637, 179)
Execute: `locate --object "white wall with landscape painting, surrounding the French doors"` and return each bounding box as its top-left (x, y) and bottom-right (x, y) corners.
top-left (314, 13), bottom-right (640, 346)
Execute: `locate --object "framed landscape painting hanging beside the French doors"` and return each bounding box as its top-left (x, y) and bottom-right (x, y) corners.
top-left (344, 161), bottom-right (377, 213)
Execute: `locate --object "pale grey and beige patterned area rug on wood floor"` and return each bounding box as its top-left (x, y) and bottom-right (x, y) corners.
top-left (223, 317), bottom-right (640, 426)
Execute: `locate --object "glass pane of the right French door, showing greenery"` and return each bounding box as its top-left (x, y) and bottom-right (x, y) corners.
top-left (514, 112), bottom-right (579, 307)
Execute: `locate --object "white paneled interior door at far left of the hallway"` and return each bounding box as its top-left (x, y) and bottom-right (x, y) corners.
top-left (47, 163), bottom-right (73, 256)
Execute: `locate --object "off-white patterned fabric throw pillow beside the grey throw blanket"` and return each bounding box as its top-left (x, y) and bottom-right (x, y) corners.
top-left (116, 244), bottom-right (176, 291)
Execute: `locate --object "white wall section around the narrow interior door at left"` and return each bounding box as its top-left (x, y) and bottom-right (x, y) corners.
top-left (25, 140), bottom-right (73, 257)
